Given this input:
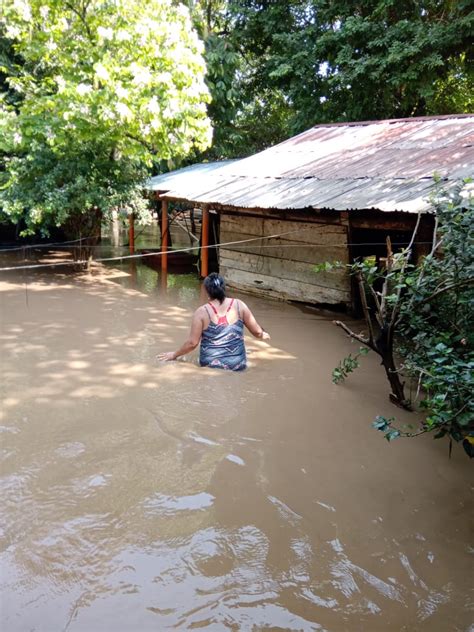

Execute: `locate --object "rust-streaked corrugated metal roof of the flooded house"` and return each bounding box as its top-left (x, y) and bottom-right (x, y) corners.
top-left (155, 115), bottom-right (474, 212)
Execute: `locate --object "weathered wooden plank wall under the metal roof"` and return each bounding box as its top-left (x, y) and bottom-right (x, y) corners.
top-left (219, 213), bottom-right (350, 305)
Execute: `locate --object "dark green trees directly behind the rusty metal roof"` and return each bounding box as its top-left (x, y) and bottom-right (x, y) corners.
top-left (194, 0), bottom-right (474, 156)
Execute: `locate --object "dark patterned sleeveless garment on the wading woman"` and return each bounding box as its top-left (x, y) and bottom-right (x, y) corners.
top-left (199, 299), bottom-right (247, 371)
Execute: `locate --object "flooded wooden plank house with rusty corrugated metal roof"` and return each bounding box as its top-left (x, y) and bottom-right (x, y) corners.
top-left (146, 115), bottom-right (474, 306)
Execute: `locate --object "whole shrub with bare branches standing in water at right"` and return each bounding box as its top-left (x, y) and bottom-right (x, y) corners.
top-left (318, 191), bottom-right (474, 456)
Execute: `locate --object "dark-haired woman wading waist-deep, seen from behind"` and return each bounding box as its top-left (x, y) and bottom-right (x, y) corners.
top-left (158, 272), bottom-right (270, 371)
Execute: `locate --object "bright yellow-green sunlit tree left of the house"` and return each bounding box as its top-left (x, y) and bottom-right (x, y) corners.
top-left (0, 0), bottom-right (211, 242)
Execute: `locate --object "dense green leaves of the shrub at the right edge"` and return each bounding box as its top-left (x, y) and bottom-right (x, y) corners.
top-left (399, 188), bottom-right (474, 453)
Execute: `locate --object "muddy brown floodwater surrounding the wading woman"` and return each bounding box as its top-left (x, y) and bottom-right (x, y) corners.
top-left (0, 267), bottom-right (473, 632)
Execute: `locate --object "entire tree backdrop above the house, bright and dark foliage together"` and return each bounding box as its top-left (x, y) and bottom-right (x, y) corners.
top-left (0, 0), bottom-right (474, 237)
